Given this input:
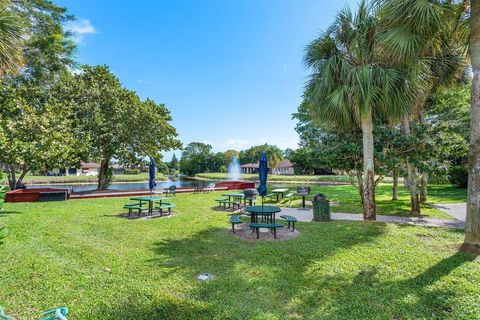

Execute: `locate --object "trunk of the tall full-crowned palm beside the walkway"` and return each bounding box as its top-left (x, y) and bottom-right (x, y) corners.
top-left (361, 111), bottom-right (377, 220)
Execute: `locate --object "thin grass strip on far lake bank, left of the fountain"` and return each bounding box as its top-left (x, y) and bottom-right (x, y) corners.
top-left (18, 173), bottom-right (167, 184)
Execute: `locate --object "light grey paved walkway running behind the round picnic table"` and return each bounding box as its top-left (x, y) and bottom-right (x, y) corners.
top-left (279, 208), bottom-right (465, 229)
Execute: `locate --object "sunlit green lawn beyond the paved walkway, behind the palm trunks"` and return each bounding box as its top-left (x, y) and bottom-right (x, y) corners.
top-left (270, 184), bottom-right (467, 219)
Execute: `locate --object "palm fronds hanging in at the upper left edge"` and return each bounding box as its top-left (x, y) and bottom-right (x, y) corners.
top-left (0, 1), bottom-right (24, 78)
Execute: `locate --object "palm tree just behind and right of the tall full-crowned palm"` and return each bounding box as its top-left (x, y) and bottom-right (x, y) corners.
top-left (381, 0), bottom-right (466, 215)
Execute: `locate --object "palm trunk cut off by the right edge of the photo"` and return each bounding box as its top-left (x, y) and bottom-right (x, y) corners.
top-left (462, 0), bottom-right (480, 253)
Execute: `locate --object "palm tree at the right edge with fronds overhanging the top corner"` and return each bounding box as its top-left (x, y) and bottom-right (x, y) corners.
top-left (380, 0), bottom-right (480, 252)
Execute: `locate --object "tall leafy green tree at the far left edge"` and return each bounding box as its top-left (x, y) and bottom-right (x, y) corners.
top-left (0, 0), bottom-right (82, 188)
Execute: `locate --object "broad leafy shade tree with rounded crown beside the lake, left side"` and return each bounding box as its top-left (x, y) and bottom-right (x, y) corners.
top-left (65, 66), bottom-right (181, 190)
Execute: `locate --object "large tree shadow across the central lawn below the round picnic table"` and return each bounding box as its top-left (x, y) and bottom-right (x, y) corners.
top-left (96, 222), bottom-right (385, 319)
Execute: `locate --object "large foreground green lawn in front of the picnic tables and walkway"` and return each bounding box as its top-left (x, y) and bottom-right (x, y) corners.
top-left (0, 190), bottom-right (480, 320)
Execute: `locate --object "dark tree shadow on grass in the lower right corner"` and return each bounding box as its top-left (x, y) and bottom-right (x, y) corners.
top-left (299, 244), bottom-right (478, 319)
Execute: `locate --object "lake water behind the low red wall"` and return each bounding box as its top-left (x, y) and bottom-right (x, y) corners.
top-left (27, 180), bottom-right (219, 192)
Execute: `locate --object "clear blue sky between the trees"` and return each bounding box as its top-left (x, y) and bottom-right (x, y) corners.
top-left (56, 0), bottom-right (356, 160)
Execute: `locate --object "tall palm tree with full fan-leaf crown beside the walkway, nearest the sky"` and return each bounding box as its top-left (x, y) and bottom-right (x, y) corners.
top-left (305, 1), bottom-right (411, 220)
